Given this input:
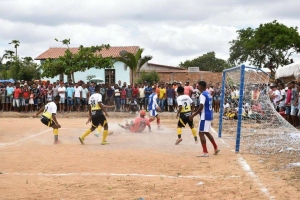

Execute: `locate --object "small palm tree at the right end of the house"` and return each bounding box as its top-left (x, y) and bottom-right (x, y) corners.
top-left (116, 49), bottom-right (152, 84)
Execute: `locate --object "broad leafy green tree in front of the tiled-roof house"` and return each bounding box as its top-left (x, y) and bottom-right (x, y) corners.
top-left (41, 39), bottom-right (113, 82)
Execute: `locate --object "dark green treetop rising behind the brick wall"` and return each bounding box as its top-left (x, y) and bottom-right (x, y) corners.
top-left (179, 51), bottom-right (230, 72)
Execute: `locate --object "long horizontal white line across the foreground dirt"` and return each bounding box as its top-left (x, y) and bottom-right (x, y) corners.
top-left (0, 172), bottom-right (240, 179)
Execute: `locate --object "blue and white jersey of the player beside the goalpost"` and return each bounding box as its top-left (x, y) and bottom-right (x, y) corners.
top-left (199, 91), bottom-right (213, 121)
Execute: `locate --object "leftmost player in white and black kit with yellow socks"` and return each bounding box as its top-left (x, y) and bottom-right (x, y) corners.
top-left (33, 96), bottom-right (61, 144)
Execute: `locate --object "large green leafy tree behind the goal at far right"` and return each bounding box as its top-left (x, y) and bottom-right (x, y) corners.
top-left (228, 20), bottom-right (300, 74)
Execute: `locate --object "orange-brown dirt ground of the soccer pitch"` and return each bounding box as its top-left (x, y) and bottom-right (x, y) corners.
top-left (0, 113), bottom-right (300, 200)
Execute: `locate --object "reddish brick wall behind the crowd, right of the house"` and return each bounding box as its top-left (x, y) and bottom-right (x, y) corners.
top-left (158, 72), bottom-right (222, 85)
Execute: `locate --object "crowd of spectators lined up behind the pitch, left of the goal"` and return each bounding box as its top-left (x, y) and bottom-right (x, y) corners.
top-left (0, 80), bottom-right (221, 113)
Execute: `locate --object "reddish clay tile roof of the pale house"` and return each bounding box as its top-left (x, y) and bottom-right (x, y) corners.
top-left (35, 46), bottom-right (139, 60)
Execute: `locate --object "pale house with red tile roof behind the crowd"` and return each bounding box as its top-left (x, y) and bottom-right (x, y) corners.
top-left (35, 46), bottom-right (139, 84)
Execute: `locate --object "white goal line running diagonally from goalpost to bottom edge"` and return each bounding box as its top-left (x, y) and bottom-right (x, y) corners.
top-left (212, 128), bottom-right (274, 199)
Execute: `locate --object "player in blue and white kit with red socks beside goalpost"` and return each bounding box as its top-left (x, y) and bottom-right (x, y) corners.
top-left (189, 81), bottom-right (220, 157)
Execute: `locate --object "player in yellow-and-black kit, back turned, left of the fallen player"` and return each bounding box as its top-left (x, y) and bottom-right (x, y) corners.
top-left (79, 85), bottom-right (109, 145)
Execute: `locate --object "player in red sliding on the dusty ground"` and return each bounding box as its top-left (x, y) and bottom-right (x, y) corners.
top-left (119, 110), bottom-right (151, 133)
